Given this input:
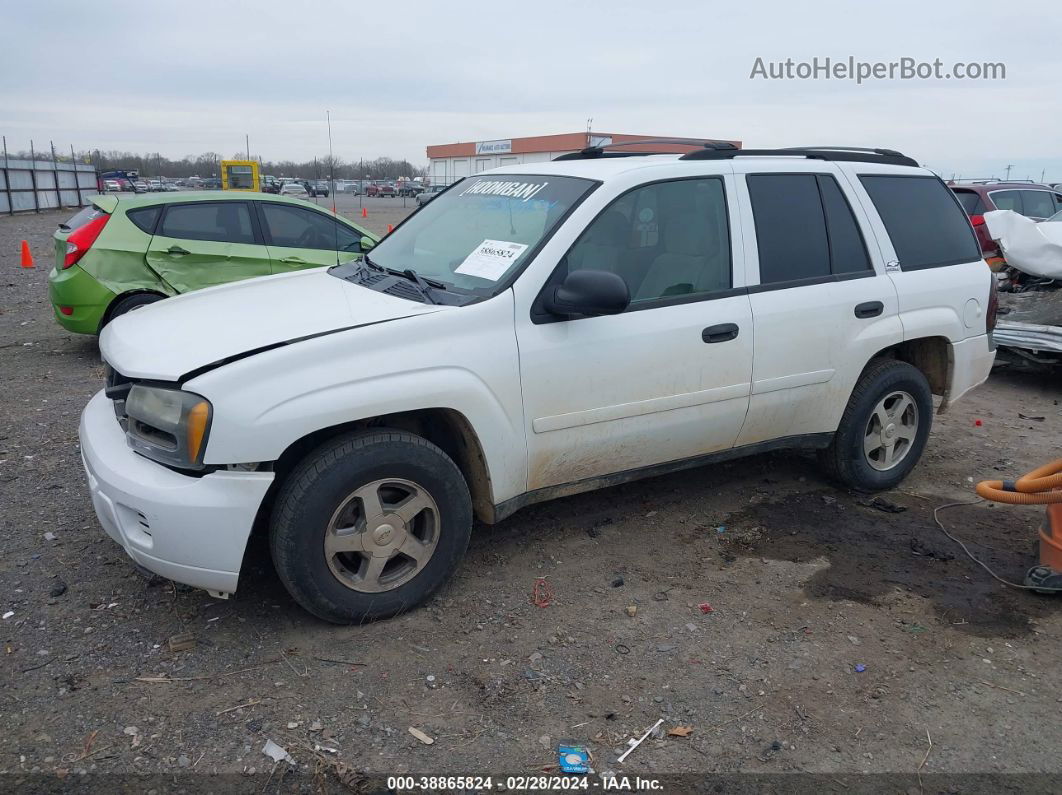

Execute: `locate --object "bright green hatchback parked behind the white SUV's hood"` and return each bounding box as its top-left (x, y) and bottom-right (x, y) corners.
top-left (48, 192), bottom-right (379, 334)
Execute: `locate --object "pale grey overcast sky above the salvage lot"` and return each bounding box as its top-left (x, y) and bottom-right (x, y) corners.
top-left (0, 0), bottom-right (1062, 182)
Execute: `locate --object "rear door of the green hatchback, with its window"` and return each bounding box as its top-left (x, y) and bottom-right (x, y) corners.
top-left (147, 201), bottom-right (270, 293)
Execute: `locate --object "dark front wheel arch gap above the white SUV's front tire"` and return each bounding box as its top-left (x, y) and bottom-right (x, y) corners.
top-left (273, 408), bottom-right (496, 524)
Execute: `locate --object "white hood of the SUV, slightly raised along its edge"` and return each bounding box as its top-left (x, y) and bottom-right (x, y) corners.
top-left (100, 269), bottom-right (451, 381)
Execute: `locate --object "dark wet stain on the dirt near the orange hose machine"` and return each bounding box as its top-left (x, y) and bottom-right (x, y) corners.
top-left (719, 491), bottom-right (1058, 638)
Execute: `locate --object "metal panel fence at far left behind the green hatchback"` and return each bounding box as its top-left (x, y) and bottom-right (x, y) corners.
top-left (0, 141), bottom-right (99, 215)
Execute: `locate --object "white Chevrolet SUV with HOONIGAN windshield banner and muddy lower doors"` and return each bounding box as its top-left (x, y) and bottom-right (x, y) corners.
top-left (81, 144), bottom-right (994, 622)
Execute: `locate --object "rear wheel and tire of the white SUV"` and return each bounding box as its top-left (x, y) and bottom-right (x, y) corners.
top-left (820, 359), bottom-right (932, 491)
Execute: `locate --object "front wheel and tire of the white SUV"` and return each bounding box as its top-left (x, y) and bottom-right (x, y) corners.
top-left (270, 430), bottom-right (473, 624)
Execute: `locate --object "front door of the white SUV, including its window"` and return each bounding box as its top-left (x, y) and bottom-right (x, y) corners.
top-left (516, 176), bottom-right (753, 490)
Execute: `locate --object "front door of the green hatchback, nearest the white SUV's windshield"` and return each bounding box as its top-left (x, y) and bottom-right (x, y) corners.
top-left (257, 202), bottom-right (361, 273)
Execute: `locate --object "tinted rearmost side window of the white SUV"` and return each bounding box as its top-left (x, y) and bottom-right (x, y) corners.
top-left (859, 174), bottom-right (981, 271)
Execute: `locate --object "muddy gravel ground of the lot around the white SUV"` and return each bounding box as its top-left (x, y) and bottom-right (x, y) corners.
top-left (0, 202), bottom-right (1062, 792)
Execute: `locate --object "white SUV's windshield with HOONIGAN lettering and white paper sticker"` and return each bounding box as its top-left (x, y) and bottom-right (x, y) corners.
top-left (370, 174), bottom-right (594, 294)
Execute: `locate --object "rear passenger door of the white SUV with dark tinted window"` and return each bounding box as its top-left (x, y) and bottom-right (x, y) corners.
top-left (735, 160), bottom-right (902, 446)
